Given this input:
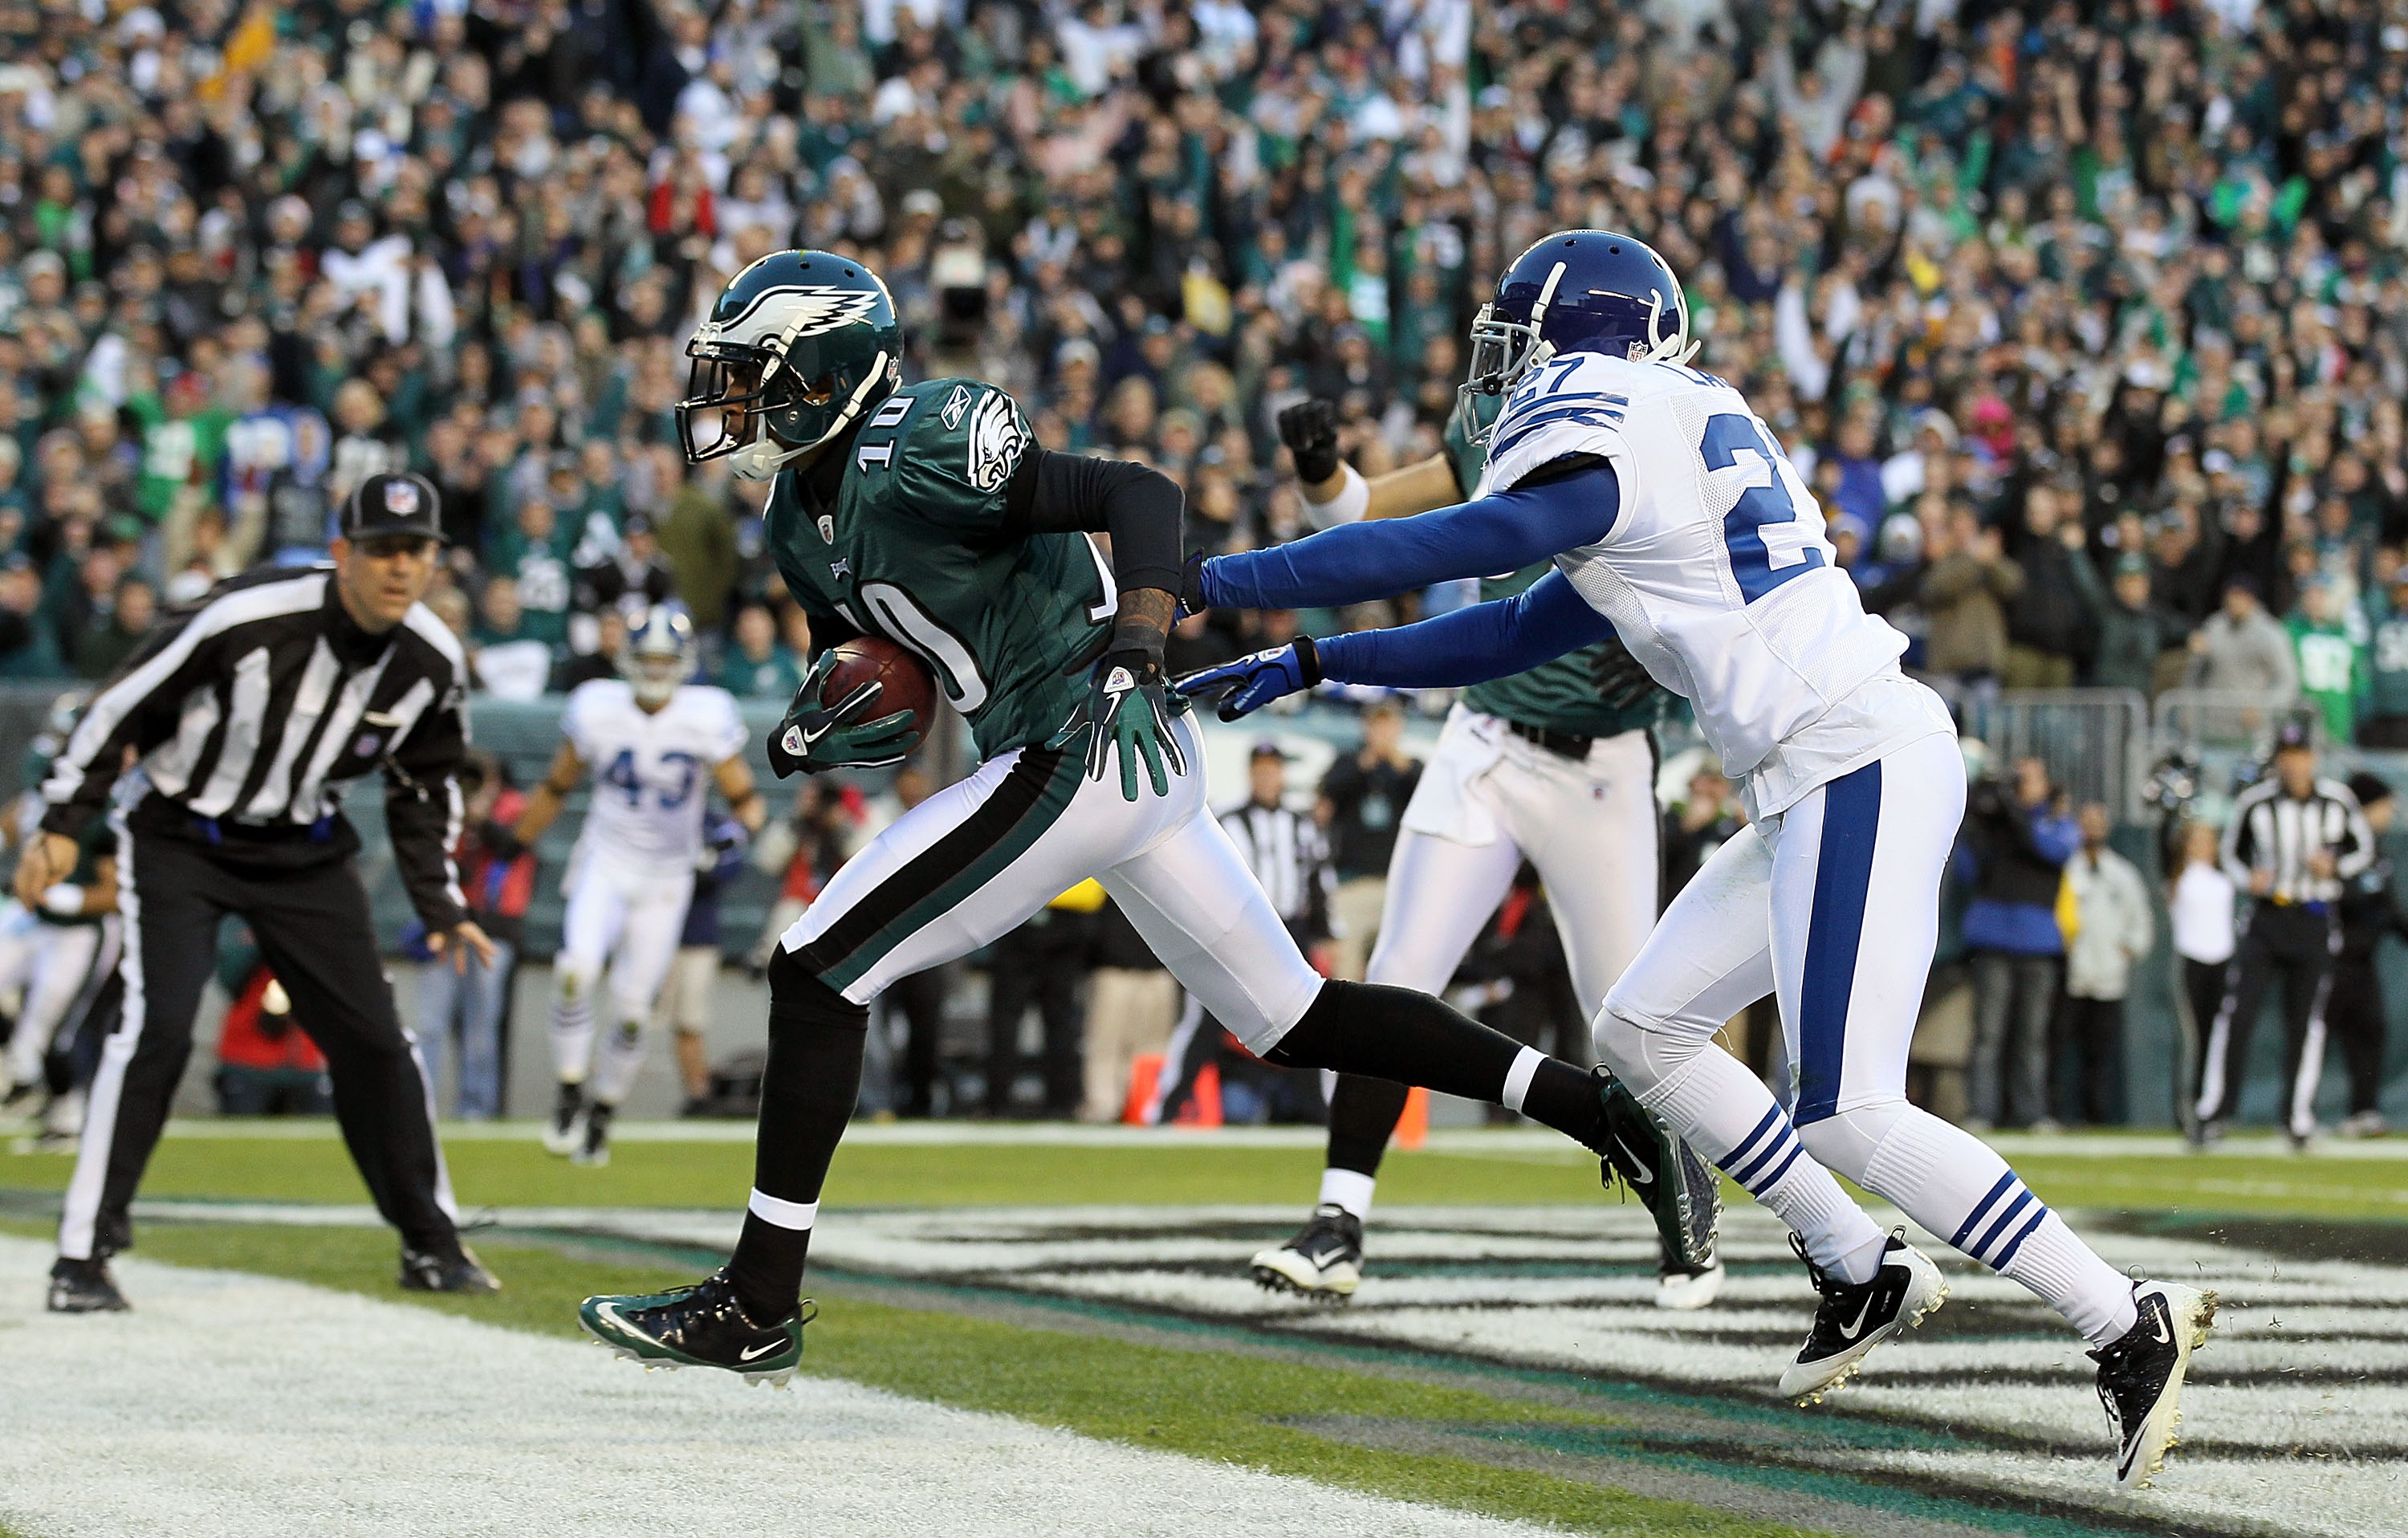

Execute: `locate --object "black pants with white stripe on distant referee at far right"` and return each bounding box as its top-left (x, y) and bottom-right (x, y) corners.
top-left (2199, 902), bottom-right (2341, 1138)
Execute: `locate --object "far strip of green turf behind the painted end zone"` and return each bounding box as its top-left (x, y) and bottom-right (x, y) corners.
top-left (0, 1133), bottom-right (2408, 1220)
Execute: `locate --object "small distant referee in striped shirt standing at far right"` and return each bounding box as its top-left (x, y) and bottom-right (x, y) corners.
top-left (2191, 720), bottom-right (2374, 1148)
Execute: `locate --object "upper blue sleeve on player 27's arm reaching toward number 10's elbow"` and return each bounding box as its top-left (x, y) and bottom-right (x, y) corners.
top-left (1204, 462), bottom-right (1623, 609)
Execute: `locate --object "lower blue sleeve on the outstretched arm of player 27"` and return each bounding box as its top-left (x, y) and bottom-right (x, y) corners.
top-left (1312, 568), bottom-right (1613, 689)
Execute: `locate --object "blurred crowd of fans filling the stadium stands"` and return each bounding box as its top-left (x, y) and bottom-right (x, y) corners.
top-left (0, 0), bottom-right (2408, 744)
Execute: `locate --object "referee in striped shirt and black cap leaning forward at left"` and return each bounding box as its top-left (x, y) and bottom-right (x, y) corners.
top-left (17, 474), bottom-right (498, 1314)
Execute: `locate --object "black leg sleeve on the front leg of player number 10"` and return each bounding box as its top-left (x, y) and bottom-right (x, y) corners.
top-left (727, 948), bottom-right (869, 1321)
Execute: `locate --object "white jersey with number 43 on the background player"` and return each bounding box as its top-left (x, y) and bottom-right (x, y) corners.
top-left (561, 679), bottom-right (744, 864)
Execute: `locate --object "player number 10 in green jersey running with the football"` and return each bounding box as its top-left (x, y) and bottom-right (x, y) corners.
top-left (580, 250), bottom-right (1714, 1381)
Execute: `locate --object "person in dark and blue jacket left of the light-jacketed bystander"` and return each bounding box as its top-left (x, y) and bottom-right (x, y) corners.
top-left (1958, 759), bottom-right (2081, 1131)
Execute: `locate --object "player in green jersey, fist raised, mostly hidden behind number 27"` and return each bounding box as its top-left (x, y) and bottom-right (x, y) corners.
top-left (1252, 390), bottom-right (1724, 1309)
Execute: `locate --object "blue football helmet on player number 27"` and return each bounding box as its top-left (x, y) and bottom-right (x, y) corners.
top-left (1457, 229), bottom-right (1698, 443)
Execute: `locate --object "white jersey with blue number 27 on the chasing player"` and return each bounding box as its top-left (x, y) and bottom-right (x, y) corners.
top-left (1479, 352), bottom-right (1929, 779)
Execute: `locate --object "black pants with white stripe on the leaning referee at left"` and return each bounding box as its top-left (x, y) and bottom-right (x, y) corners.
top-left (58, 828), bottom-right (460, 1259)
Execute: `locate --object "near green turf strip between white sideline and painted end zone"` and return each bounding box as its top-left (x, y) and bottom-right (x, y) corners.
top-left (0, 1223), bottom-right (1808, 1538)
